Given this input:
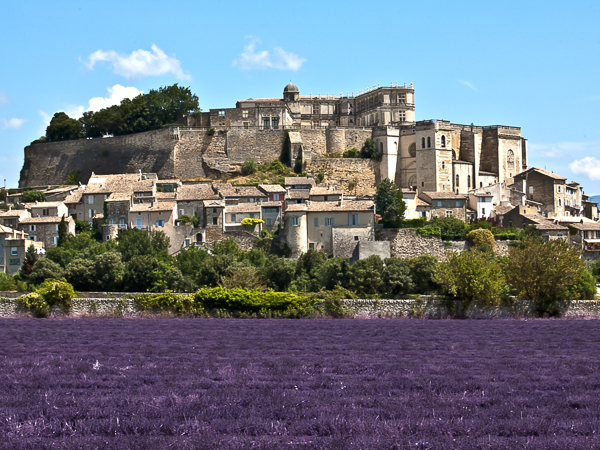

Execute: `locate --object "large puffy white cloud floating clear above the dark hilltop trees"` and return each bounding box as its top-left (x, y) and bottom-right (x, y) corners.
top-left (84, 44), bottom-right (192, 80)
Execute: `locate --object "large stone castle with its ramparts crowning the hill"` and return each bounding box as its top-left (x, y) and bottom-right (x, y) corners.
top-left (19, 83), bottom-right (527, 195)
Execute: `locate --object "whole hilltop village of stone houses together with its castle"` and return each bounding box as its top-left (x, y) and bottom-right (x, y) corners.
top-left (0, 84), bottom-right (600, 274)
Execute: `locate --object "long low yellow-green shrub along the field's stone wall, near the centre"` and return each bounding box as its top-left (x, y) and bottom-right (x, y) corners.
top-left (194, 287), bottom-right (313, 313)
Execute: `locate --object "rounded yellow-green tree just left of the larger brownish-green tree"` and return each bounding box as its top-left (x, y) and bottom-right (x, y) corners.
top-left (437, 250), bottom-right (506, 310)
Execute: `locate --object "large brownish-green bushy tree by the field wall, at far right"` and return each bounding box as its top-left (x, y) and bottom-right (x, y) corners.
top-left (507, 237), bottom-right (585, 315)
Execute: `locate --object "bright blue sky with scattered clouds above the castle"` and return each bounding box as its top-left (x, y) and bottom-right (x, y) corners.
top-left (0, 0), bottom-right (600, 195)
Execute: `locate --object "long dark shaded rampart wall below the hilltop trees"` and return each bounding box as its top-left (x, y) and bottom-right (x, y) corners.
top-left (19, 129), bottom-right (176, 187)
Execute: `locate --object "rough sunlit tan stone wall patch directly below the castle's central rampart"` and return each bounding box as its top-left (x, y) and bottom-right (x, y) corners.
top-left (306, 158), bottom-right (381, 195)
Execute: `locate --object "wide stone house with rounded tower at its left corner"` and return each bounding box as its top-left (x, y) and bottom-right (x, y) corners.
top-left (284, 201), bottom-right (375, 258)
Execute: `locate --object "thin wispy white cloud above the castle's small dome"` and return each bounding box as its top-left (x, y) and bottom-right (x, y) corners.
top-left (233, 36), bottom-right (306, 71)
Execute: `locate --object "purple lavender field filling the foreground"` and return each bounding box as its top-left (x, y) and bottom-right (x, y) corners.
top-left (0, 318), bottom-right (600, 449)
